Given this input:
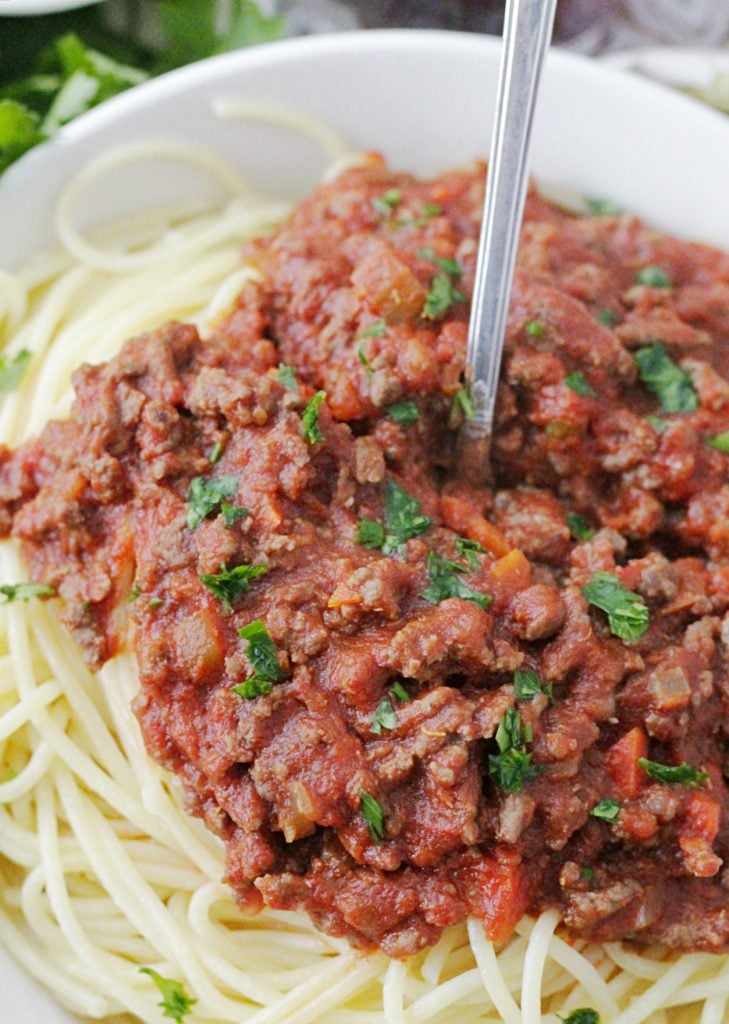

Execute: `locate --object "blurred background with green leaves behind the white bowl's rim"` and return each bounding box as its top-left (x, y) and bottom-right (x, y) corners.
top-left (0, 0), bottom-right (729, 172)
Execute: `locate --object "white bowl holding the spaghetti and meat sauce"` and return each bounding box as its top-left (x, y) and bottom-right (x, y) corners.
top-left (0, 25), bottom-right (729, 1024)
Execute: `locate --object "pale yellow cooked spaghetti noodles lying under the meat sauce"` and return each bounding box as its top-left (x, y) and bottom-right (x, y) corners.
top-left (0, 134), bottom-right (729, 1024)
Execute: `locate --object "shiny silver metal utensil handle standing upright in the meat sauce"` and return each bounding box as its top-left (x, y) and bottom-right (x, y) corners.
top-left (459, 0), bottom-right (557, 485)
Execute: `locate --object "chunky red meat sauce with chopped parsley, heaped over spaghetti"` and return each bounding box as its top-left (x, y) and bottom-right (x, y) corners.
top-left (0, 158), bottom-right (729, 956)
